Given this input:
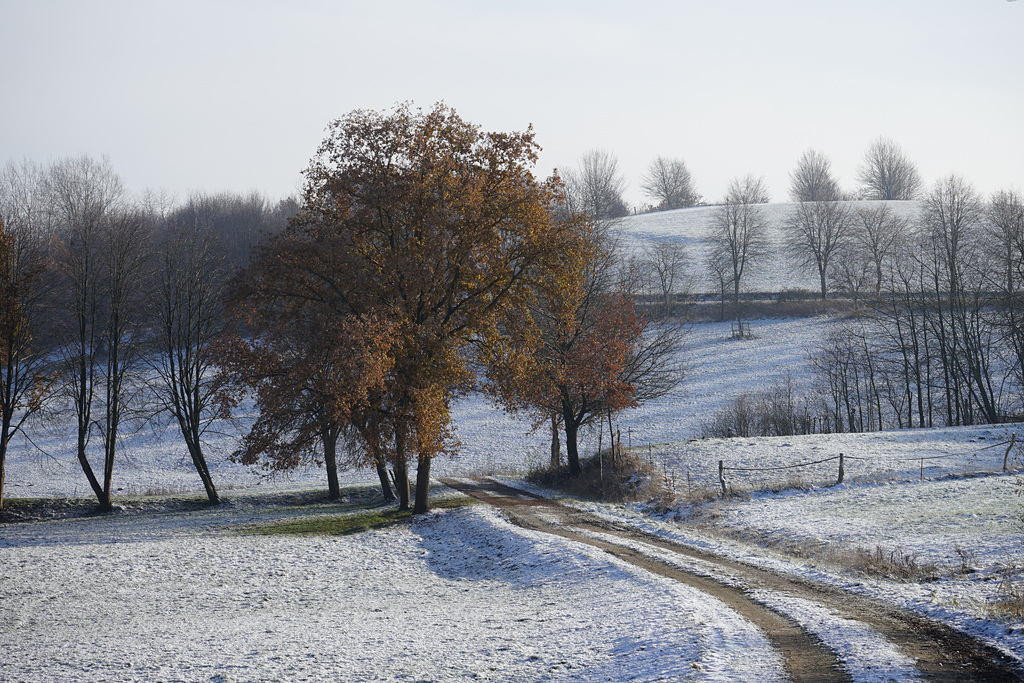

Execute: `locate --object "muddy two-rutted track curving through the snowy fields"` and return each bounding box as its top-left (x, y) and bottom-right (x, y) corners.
top-left (442, 479), bottom-right (1024, 682)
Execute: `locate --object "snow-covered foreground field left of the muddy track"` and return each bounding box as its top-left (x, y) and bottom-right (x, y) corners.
top-left (0, 503), bottom-right (783, 681)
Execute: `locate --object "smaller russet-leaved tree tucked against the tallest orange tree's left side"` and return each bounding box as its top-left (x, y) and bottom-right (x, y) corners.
top-left (218, 272), bottom-right (392, 500)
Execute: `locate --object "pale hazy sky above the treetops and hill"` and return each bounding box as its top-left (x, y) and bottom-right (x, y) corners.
top-left (0, 0), bottom-right (1024, 205)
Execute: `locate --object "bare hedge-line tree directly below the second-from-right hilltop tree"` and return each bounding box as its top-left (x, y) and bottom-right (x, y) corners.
top-left (785, 200), bottom-right (851, 300)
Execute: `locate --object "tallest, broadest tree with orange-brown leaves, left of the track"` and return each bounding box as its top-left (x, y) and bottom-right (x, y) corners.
top-left (227, 104), bottom-right (580, 512)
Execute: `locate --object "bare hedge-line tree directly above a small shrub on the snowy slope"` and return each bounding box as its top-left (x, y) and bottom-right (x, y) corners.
top-left (707, 175), bottom-right (769, 308)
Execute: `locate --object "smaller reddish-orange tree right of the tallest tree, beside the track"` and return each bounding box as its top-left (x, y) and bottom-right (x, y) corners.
top-left (481, 235), bottom-right (683, 476)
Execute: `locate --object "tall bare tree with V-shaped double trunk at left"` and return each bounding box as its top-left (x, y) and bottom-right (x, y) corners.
top-left (46, 156), bottom-right (150, 510)
